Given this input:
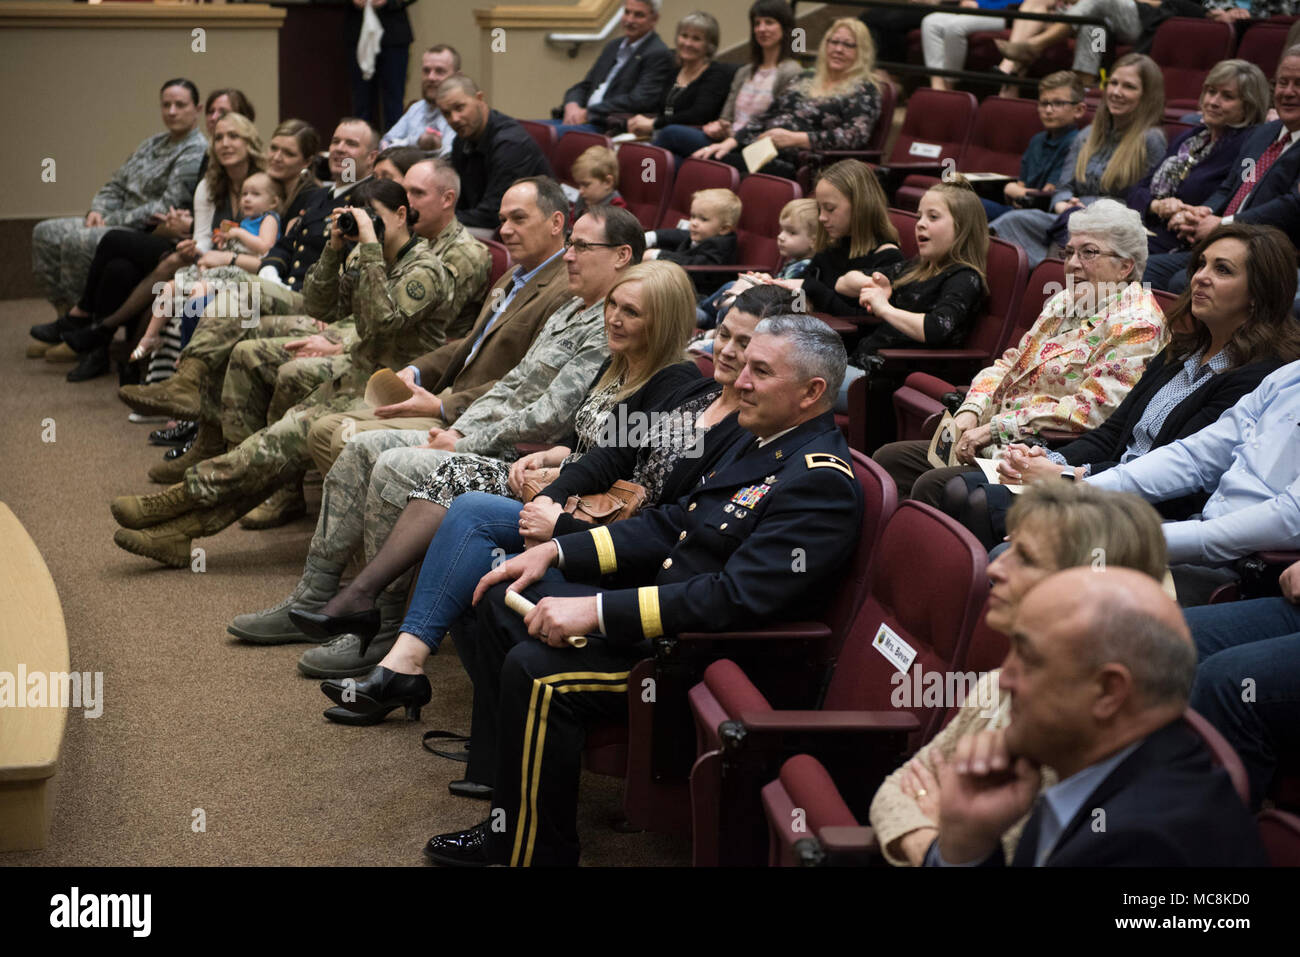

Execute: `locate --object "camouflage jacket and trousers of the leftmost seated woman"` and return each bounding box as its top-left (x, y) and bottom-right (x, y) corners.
top-left (31, 126), bottom-right (208, 312)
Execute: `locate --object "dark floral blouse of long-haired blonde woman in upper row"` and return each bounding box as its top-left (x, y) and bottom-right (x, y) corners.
top-left (732, 70), bottom-right (880, 163)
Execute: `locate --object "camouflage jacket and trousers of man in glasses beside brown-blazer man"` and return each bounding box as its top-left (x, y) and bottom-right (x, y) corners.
top-left (297, 298), bottom-right (608, 590)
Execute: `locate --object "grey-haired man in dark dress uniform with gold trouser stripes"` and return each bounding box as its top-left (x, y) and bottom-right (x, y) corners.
top-left (425, 315), bottom-right (862, 866)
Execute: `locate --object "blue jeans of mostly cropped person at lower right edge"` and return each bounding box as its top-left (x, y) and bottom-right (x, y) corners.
top-left (1183, 598), bottom-right (1300, 807)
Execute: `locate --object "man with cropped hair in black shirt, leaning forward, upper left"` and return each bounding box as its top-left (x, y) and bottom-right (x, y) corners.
top-left (437, 73), bottom-right (551, 231)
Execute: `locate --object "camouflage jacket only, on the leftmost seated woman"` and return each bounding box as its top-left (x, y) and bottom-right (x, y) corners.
top-left (90, 126), bottom-right (208, 229)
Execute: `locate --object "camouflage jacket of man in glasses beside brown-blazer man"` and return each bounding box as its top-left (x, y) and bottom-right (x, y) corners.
top-left (455, 296), bottom-right (610, 462)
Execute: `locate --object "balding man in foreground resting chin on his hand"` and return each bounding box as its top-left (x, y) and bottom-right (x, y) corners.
top-left (926, 568), bottom-right (1266, 867)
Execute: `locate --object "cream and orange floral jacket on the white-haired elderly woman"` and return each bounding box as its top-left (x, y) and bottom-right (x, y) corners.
top-left (958, 282), bottom-right (1169, 445)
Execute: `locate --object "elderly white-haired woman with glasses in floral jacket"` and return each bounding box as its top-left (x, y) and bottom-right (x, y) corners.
top-left (875, 199), bottom-right (1169, 505)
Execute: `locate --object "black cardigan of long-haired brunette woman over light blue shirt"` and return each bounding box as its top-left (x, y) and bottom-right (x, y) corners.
top-left (1058, 346), bottom-right (1283, 520)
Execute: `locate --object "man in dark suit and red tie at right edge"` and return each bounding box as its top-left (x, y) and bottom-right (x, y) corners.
top-left (1143, 46), bottom-right (1300, 293)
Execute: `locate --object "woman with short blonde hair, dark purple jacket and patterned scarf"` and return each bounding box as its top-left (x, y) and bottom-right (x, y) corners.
top-left (1128, 60), bottom-right (1270, 254)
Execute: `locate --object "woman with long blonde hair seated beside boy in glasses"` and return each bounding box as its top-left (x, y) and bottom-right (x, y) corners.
top-left (992, 53), bottom-right (1165, 268)
